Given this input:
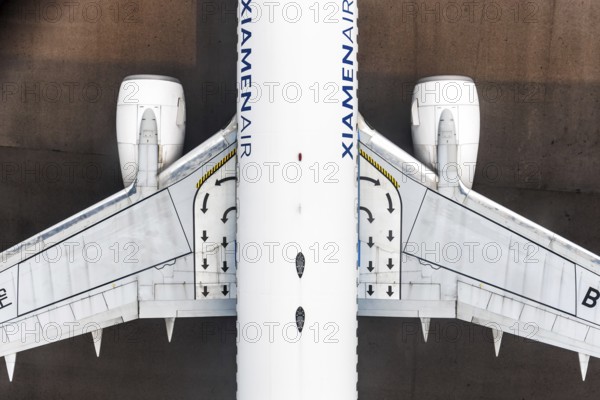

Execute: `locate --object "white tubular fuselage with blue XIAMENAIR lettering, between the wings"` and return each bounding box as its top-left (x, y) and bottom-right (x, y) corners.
top-left (237, 0), bottom-right (358, 400)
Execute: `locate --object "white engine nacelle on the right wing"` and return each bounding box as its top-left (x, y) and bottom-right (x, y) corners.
top-left (411, 75), bottom-right (479, 188)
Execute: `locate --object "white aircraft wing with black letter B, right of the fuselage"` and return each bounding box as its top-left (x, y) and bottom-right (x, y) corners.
top-left (359, 115), bottom-right (600, 379)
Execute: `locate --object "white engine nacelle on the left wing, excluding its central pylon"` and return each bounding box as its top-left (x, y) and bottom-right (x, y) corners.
top-left (117, 75), bottom-right (185, 187)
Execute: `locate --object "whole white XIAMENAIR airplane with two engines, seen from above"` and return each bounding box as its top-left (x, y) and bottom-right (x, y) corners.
top-left (0, 0), bottom-right (600, 399)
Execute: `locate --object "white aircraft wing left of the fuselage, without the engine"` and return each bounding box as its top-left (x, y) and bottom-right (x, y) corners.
top-left (0, 121), bottom-right (236, 379)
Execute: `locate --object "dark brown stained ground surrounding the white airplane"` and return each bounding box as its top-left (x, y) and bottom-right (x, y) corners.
top-left (0, 0), bottom-right (600, 400)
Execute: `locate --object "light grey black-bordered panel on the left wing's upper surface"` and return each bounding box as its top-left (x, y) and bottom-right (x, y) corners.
top-left (18, 191), bottom-right (191, 314)
